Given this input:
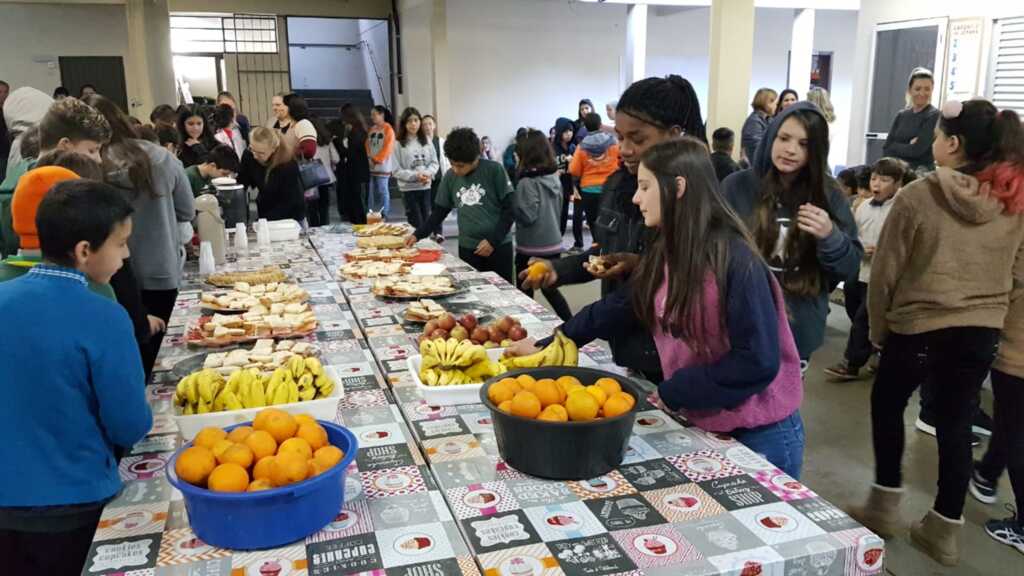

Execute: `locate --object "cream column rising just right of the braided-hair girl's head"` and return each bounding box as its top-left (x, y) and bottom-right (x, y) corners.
top-left (708, 0), bottom-right (754, 158)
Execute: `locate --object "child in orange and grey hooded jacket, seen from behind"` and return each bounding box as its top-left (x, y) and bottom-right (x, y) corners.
top-left (569, 112), bottom-right (618, 250)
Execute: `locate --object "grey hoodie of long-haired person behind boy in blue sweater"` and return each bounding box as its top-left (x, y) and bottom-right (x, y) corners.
top-left (108, 140), bottom-right (196, 290)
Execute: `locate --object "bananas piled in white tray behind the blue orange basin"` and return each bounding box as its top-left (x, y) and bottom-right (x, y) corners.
top-left (174, 357), bottom-right (335, 415)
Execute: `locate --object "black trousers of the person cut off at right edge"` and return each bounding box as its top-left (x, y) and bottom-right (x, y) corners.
top-left (978, 370), bottom-right (1024, 522)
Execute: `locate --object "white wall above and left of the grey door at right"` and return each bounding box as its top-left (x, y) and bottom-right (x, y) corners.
top-left (849, 0), bottom-right (1024, 164)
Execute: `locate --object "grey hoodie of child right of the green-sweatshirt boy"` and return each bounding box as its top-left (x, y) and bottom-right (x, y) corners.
top-left (512, 172), bottom-right (562, 255)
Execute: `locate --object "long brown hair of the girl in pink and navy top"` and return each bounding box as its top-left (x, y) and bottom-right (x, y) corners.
top-left (632, 136), bottom-right (757, 357)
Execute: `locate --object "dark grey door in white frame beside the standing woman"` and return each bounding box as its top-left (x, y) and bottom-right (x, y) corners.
top-left (864, 20), bottom-right (945, 164)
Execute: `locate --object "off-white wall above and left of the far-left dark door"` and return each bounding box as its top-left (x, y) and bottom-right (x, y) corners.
top-left (0, 3), bottom-right (128, 93)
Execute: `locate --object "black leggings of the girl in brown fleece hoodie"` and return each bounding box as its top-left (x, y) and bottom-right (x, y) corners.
top-left (871, 327), bottom-right (999, 519)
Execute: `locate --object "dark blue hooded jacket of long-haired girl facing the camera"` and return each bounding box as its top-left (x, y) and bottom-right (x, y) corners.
top-left (722, 102), bottom-right (864, 360)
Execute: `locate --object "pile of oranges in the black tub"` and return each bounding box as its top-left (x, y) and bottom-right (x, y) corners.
top-left (487, 374), bottom-right (636, 422)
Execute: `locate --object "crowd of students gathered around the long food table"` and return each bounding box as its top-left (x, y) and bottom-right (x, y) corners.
top-left (0, 66), bottom-right (1024, 573)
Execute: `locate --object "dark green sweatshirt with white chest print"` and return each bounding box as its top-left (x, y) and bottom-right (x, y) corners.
top-left (430, 158), bottom-right (513, 249)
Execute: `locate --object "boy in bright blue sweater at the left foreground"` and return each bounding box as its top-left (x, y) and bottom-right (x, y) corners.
top-left (0, 179), bottom-right (153, 574)
